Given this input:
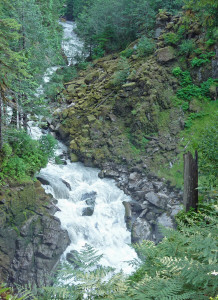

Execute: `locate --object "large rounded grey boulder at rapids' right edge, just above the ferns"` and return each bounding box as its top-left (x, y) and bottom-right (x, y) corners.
top-left (131, 218), bottom-right (151, 243)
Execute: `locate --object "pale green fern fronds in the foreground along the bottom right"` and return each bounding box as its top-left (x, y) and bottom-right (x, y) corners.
top-left (35, 201), bottom-right (218, 300)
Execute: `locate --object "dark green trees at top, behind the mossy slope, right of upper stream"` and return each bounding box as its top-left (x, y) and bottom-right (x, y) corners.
top-left (66, 0), bottom-right (183, 58)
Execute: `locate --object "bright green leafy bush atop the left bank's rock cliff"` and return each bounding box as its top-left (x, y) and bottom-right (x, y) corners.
top-left (0, 130), bottom-right (56, 183)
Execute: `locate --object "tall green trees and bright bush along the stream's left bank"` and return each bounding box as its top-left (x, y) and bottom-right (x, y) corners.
top-left (0, 0), bottom-right (63, 184)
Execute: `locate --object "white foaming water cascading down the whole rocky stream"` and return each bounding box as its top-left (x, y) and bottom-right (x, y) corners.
top-left (29, 22), bottom-right (137, 274)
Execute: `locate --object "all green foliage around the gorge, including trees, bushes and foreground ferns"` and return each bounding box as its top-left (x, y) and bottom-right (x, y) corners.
top-left (0, 0), bottom-right (218, 300)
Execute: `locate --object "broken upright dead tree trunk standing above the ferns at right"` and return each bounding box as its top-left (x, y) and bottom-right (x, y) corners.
top-left (183, 151), bottom-right (198, 211)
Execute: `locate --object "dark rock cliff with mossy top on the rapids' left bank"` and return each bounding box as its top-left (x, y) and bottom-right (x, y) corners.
top-left (0, 182), bottom-right (70, 287)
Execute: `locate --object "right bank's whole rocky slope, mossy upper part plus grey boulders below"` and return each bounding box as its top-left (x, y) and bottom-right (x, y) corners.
top-left (45, 12), bottom-right (217, 242)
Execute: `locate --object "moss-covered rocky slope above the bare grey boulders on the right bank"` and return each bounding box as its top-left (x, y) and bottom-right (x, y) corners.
top-left (53, 12), bottom-right (217, 185)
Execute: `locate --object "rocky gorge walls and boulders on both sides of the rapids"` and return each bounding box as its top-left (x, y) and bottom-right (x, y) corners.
top-left (0, 8), bottom-right (217, 287)
